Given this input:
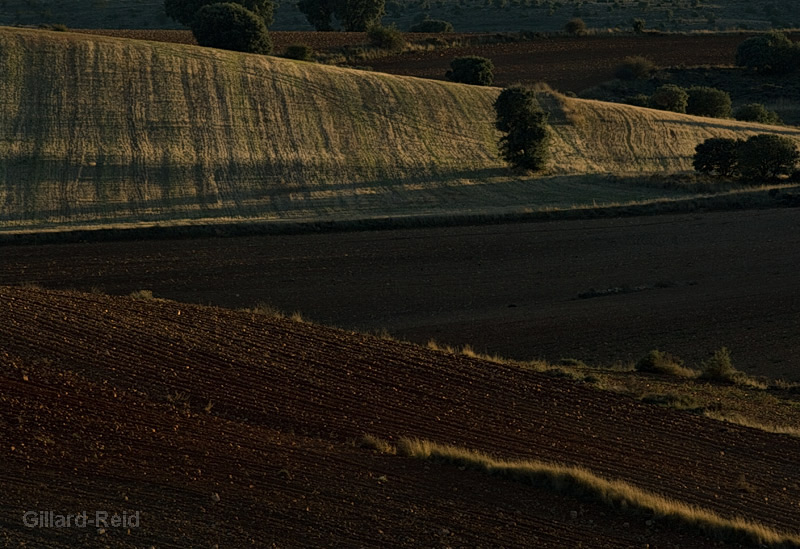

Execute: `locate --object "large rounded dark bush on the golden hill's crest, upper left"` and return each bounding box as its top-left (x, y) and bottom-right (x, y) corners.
top-left (192, 2), bottom-right (272, 54)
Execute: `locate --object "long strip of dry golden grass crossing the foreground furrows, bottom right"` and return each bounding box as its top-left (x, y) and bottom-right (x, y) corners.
top-left (397, 438), bottom-right (800, 547)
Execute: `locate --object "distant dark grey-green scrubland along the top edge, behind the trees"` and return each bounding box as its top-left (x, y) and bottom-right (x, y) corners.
top-left (0, 0), bottom-right (800, 32)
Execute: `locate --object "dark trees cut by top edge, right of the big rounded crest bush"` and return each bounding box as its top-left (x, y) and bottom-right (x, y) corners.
top-left (297, 0), bottom-right (385, 32)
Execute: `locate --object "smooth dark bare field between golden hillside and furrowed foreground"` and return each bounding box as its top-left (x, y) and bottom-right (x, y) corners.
top-left (6, 209), bottom-right (800, 381)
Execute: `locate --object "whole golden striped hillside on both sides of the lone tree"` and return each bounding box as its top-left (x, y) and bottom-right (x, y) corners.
top-left (0, 29), bottom-right (800, 231)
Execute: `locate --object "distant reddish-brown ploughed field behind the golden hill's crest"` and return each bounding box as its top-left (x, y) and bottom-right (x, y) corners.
top-left (70, 29), bottom-right (747, 92)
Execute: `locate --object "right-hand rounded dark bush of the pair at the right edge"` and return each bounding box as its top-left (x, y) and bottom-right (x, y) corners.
top-left (738, 134), bottom-right (800, 179)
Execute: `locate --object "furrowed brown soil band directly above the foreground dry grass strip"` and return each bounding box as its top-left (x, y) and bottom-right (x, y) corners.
top-left (0, 289), bottom-right (800, 529)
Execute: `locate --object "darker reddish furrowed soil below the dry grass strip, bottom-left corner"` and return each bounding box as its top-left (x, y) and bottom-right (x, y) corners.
top-left (0, 336), bottom-right (720, 547)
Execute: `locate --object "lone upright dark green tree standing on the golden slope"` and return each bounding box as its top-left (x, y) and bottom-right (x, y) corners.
top-left (494, 86), bottom-right (550, 170)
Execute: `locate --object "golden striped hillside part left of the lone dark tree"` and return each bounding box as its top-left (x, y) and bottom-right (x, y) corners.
top-left (0, 29), bottom-right (502, 229)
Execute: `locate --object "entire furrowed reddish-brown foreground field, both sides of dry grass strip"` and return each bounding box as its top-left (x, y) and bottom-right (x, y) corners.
top-left (0, 288), bottom-right (800, 547)
